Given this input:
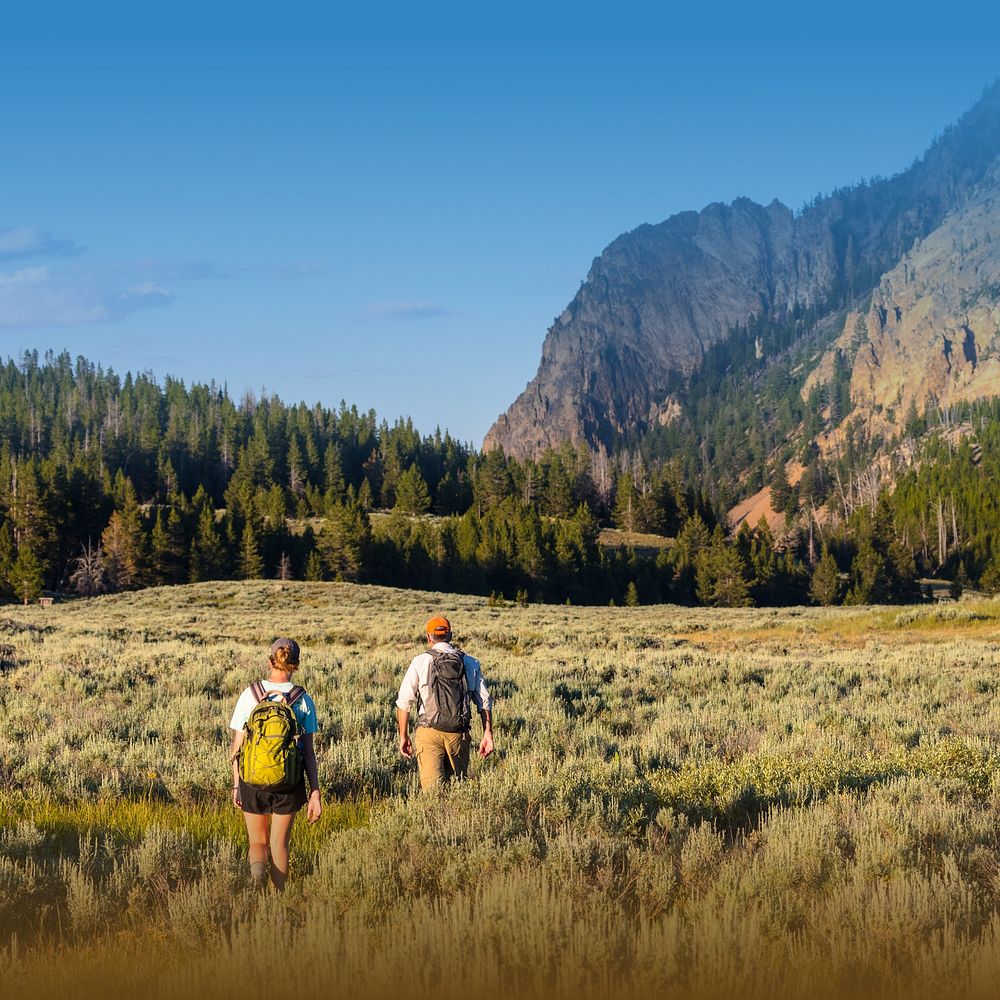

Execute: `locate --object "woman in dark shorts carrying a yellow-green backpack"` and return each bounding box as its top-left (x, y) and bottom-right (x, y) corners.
top-left (229, 639), bottom-right (323, 891)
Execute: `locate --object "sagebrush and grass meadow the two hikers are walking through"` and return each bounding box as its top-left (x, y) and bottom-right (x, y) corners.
top-left (0, 582), bottom-right (1000, 998)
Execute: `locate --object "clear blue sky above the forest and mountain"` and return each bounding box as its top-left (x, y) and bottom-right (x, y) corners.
top-left (0, 3), bottom-right (1000, 444)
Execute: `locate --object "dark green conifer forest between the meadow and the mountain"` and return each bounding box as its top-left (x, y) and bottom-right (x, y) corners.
top-left (0, 353), bottom-right (1000, 606)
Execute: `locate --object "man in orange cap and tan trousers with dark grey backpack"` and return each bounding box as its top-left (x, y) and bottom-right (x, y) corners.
top-left (396, 617), bottom-right (493, 789)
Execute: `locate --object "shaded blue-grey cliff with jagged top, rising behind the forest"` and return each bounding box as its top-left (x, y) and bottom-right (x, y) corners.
top-left (484, 85), bottom-right (1000, 456)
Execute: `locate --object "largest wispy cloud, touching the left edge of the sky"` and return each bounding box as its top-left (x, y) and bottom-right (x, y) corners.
top-left (0, 266), bottom-right (174, 328)
